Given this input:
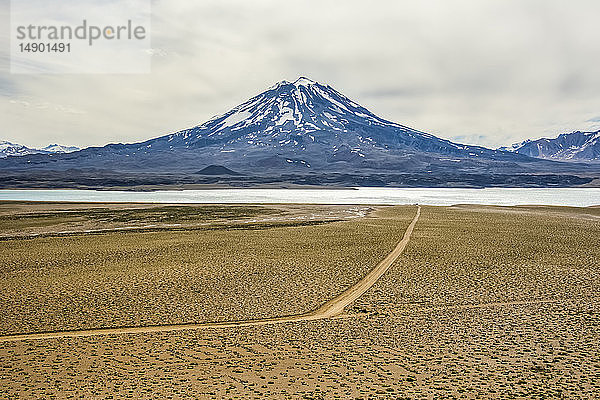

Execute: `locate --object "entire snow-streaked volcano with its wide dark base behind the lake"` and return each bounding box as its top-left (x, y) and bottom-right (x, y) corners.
top-left (0, 78), bottom-right (600, 188)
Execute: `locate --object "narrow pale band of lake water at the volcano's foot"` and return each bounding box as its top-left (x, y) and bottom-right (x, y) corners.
top-left (0, 188), bottom-right (600, 207)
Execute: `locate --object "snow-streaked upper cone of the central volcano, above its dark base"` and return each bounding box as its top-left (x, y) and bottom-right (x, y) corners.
top-left (143, 77), bottom-right (510, 168)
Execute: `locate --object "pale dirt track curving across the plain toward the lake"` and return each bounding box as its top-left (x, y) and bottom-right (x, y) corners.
top-left (0, 206), bottom-right (421, 342)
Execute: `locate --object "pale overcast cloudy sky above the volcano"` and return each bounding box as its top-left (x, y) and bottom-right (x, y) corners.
top-left (0, 0), bottom-right (600, 147)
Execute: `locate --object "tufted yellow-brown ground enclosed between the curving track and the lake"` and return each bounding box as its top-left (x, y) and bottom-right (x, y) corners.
top-left (0, 206), bottom-right (411, 334)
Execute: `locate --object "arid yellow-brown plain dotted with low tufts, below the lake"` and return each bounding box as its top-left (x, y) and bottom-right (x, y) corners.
top-left (0, 202), bottom-right (600, 399)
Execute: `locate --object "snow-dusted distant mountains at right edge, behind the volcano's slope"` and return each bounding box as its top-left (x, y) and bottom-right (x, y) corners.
top-left (499, 130), bottom-right (600, 161)
